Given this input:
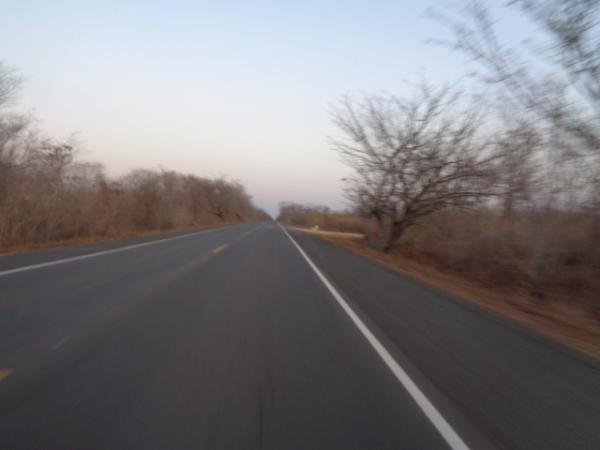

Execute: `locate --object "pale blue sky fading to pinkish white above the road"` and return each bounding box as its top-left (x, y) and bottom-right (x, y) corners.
top-left (0, 0), bottom-right (524, 212)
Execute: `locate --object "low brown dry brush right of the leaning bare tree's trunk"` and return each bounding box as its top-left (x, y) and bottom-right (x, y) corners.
top-left (395, 208), bottom-right (600, 319)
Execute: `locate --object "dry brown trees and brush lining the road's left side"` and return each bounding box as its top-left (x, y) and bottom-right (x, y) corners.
top-left (0, 64), bottom-right (267, 252)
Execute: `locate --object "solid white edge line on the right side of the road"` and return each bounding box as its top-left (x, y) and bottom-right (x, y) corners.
top-left (279, 224), bottom-right (470, 450)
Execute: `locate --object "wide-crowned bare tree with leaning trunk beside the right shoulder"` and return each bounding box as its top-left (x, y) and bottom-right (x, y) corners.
top-left (333, 83), bottom-right (497, 251)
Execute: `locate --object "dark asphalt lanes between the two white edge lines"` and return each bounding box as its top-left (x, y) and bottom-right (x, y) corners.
top-left (0, 222), bottom-right (460, 449)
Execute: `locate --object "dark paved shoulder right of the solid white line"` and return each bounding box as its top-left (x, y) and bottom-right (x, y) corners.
top-left (290, 231), bottom-right (600, 450)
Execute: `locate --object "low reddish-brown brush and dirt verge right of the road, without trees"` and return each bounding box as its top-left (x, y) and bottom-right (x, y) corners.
top-left (280, 208), bottom-right (600, 357)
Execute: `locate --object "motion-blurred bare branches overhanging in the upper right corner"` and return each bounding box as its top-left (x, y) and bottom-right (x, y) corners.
top-left (435, 0), bottom-right (600, 158)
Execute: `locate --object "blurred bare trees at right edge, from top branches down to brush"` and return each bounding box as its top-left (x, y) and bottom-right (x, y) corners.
top-left (436, 0), bottom-right (600, 261)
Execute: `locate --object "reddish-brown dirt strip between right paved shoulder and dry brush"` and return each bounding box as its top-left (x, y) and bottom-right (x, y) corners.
top-left (299, 228), bottom-right (600, 358)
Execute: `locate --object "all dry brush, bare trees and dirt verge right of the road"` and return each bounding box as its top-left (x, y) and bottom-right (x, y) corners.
top-left (280, 0), bottom-right (600, 355)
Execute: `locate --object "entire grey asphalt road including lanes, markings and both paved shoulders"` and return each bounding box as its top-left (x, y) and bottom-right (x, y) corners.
top-left (0, 222), bottom-right (600, 450)
